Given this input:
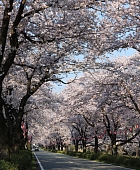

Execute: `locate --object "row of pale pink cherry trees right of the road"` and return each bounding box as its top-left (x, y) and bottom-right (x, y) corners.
top-left (61, 54), bottom-right (140, 154)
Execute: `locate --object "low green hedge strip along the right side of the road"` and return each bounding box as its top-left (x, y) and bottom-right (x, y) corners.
top-left (48, 150), bottom-right (140, 170)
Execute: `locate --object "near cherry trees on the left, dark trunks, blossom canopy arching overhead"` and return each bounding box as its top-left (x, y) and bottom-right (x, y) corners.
top-left (0, 0), bottom-right (140, 159)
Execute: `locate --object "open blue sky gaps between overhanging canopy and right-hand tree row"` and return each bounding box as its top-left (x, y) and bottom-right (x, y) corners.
top-left (53, 48), bottom-right (136, 94)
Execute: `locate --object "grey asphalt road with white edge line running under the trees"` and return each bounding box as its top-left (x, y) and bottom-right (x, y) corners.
top-left (34, 150), bottom-right (134, 170)
